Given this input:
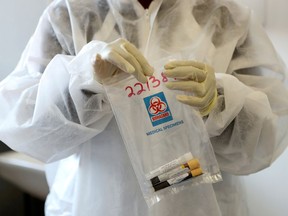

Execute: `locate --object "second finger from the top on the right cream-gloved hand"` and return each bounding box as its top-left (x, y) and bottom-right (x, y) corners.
top-left (164, 65), bottom-right (207, 82)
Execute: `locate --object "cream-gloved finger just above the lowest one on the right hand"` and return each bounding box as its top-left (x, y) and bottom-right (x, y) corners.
top-left (165, 80), bottom-right (209, 97)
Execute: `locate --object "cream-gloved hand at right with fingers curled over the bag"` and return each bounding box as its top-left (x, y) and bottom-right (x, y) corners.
top-left (164, 61), bottom-right (217, 116)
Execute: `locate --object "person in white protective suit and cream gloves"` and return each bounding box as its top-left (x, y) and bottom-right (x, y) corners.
top-left (0, 0), bottom-right (288, 216)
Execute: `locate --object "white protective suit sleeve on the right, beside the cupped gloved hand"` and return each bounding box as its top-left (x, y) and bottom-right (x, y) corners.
top-left (205, 13), bottom-right (288, 175)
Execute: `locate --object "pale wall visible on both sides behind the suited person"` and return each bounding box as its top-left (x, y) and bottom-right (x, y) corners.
top-left (0, 0), bottom-right (288, 216)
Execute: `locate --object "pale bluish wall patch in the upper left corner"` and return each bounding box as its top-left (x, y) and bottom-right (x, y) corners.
top-left (0, 0), bottom-right (48, 80)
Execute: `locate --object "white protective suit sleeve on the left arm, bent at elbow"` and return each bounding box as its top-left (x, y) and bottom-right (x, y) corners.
top-left (0, 7), bottom-right (113, 162)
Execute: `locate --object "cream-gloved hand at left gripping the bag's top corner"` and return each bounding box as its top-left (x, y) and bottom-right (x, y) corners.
top-left (94, 39), bottom-right (154, 83)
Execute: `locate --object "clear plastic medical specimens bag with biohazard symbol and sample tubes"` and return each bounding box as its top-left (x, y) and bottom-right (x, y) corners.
top-left (104, 57), bottom-right (221, 206)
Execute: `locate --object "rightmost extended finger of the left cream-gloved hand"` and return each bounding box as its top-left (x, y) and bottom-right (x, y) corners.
top-left (123, 42), bottom-right (154, 76)
